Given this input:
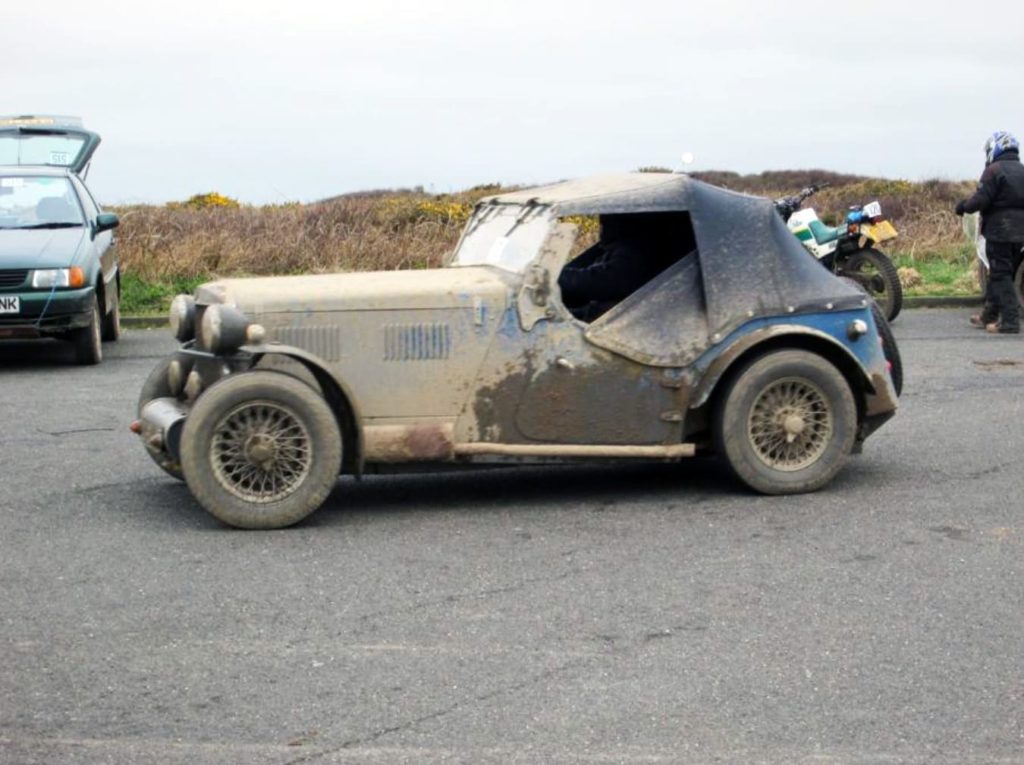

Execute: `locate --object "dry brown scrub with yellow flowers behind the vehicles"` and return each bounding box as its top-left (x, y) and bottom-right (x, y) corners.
top-left (110, 170), bottom-right (971, 284)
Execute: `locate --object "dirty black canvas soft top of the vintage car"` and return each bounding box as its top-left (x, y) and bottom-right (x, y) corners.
top-left (480, 173), bottom-right (866, 366)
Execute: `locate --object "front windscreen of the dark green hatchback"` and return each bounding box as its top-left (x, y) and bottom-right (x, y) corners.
top-left (0, 175), bottom-right (83, 228)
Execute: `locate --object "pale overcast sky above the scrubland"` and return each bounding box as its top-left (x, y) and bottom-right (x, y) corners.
top-left (8, 0), bottom-right (1024, 204)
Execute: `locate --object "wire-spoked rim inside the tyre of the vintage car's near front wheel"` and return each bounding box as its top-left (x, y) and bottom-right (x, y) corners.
top-left (210, 400), bottom-right (312, 504)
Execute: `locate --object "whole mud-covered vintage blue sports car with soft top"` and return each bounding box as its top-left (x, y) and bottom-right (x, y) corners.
top-left (135, 174), bottom-right (897, 527)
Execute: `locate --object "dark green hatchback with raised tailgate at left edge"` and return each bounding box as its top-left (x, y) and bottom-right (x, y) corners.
top-left (0, 117), bottom-right (121, 365)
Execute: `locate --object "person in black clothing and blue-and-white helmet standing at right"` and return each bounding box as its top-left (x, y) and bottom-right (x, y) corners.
top-left (956, 130), bottom-right (1024, 335)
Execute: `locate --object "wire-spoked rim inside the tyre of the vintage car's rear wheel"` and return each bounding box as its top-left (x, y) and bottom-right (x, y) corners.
top-left (748, 377), bottom-right (833, 471)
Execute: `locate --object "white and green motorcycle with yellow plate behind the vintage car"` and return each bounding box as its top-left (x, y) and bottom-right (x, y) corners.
top-left (775, 183), bottom-right (903, 322)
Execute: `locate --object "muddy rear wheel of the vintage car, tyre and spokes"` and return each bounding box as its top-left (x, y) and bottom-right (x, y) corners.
top-left (714, 350), bottom-right (857, 494)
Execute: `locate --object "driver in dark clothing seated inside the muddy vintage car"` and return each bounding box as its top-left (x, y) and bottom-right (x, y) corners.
top-left (558, 213), bottom-right (677, 322)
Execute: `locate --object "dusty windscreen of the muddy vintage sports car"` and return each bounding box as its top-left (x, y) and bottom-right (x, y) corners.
top-left (451, 205), bottom-right (552, 273)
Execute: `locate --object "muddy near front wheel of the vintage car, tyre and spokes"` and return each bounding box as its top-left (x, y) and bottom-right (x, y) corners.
top-left (181, 372), bottom-right (342, 528)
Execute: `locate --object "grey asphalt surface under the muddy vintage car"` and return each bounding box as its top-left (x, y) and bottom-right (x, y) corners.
top-left (0, 310), bottom-right (1024, 764)
